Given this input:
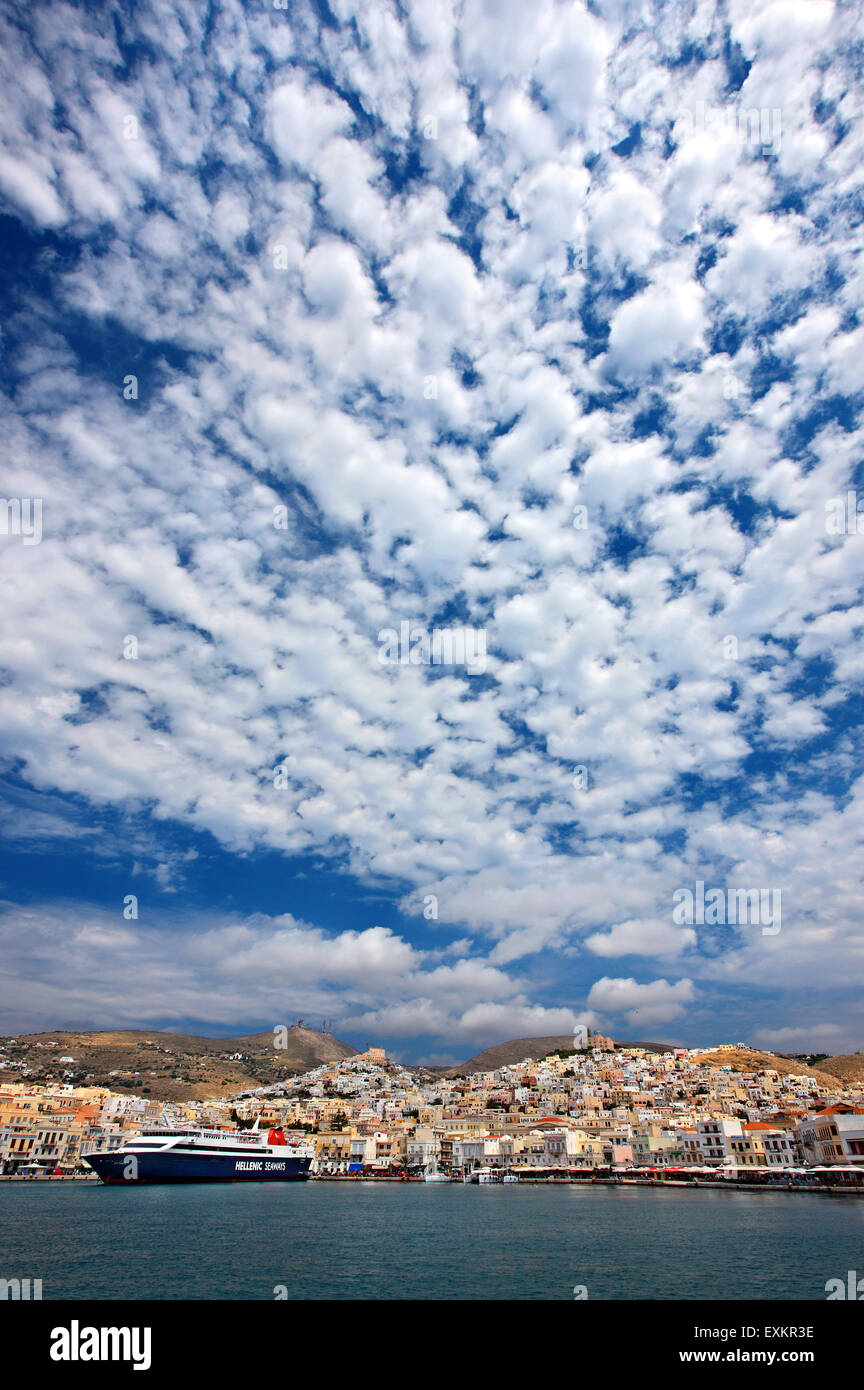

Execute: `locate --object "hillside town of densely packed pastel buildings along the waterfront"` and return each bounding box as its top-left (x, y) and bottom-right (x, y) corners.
top-left (0, 1034), bottom-right (864, 1182)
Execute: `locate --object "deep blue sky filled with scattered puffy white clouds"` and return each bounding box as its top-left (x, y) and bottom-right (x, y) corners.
top-left (0, 0), bottom-right (864, 1061)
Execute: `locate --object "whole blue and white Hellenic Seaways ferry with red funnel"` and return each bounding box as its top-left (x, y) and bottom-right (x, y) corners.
top-left (85, 1122), bottom-right (314, 1184)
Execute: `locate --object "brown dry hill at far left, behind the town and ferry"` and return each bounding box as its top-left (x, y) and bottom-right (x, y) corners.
top-left (0, 1024), bottom-right (357, 1101)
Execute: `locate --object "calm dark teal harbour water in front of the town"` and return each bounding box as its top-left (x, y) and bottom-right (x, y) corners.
top-left (0, 1183), bottom-right (864, 1300)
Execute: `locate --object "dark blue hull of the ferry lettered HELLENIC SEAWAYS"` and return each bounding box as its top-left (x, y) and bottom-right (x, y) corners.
top-left (85, 1151), bottom-right (311, 1187)
